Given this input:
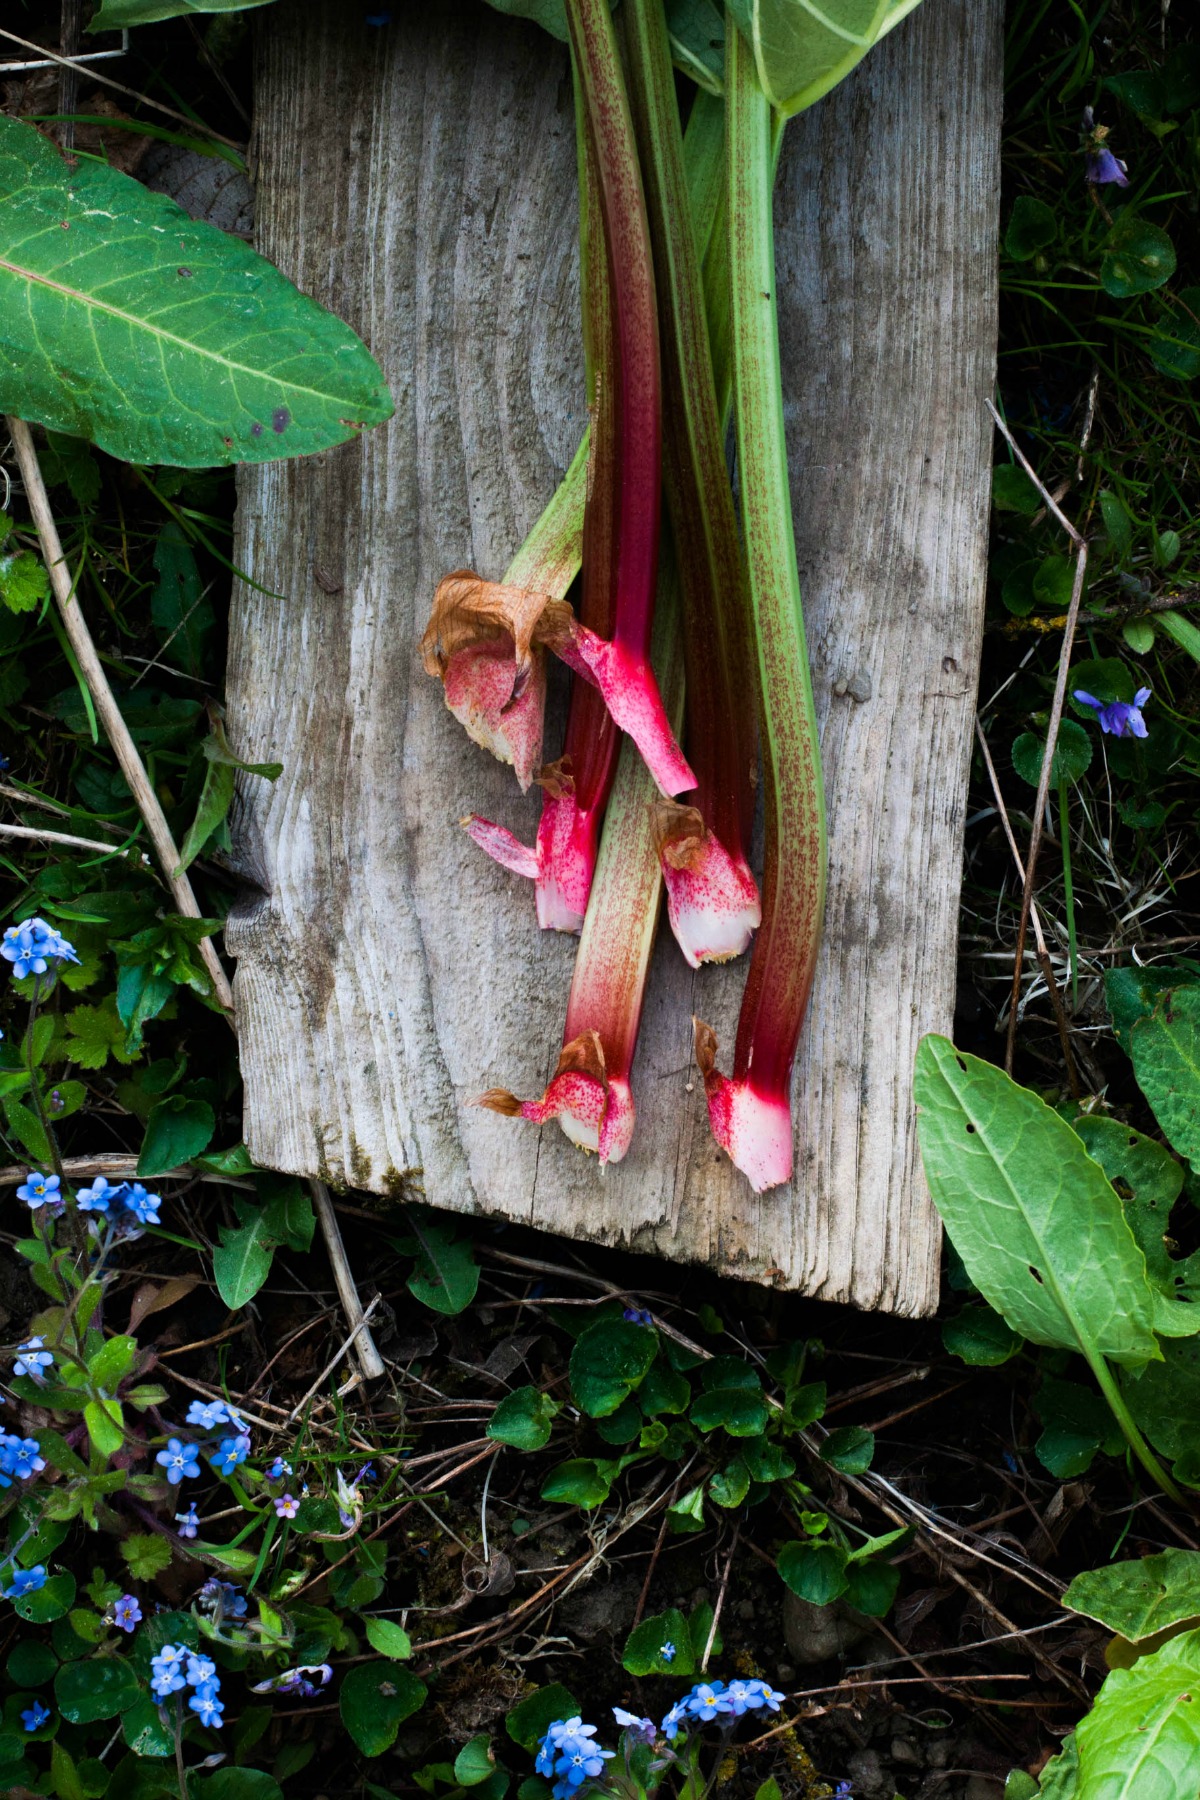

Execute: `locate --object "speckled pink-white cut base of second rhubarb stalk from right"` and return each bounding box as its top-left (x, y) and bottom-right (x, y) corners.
top-left (655, 801), bottom-right (763, 968)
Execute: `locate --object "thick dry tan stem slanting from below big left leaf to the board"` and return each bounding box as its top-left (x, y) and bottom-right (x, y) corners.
top-left (7, 418), bottom-right (234, 1024)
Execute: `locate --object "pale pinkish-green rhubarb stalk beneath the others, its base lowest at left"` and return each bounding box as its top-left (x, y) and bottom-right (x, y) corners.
top-left (479, 532), bottom-right (684, 1163)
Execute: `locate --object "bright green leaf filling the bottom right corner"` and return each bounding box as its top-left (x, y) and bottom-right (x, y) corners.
top-left (1076, 1631), bottom-right (1200, 1800)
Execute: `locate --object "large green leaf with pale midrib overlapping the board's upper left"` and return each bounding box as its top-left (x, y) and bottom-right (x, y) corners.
top-left (0, 117), bottom-right (392, 468)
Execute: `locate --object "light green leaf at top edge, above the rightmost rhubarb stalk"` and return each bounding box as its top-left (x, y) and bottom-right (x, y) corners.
top-left (727, 0), bottom-right (889, 119)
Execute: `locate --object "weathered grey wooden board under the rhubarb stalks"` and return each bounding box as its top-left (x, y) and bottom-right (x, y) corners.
top-left (227, 0), bottom-right (1000, 1314)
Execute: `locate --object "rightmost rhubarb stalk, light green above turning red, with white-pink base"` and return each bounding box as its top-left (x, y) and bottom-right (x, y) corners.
top-left (696, 31), bottom-right (826, 1193)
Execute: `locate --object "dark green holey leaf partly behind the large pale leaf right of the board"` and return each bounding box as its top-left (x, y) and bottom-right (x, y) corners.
top-left (1074, 1114), bottom-right (1200, 1337)
